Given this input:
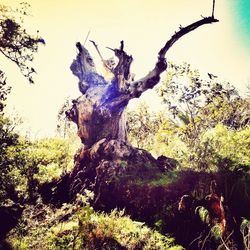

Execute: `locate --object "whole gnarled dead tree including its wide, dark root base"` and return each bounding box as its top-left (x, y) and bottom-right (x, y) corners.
top-left (36, 13), bottom-right (218, 213)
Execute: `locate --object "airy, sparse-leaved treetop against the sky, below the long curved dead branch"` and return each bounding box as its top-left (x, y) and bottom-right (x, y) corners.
top-left (157, 63), bottom-right (250, 139)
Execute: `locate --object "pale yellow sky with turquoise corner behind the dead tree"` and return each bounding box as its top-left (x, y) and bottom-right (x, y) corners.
top-left (0, 0), bottom-right (250, 137)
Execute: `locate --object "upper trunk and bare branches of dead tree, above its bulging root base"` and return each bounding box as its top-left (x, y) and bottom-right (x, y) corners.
top-left (67, 15), bottom-right (218, 148)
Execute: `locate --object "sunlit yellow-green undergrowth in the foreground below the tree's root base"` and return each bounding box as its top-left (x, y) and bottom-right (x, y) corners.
top-left (9, 191), bottom-right (183, 250)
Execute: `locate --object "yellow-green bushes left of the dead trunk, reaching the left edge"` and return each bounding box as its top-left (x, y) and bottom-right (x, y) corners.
top-left (0, 117), bottom-right (75, 203)
